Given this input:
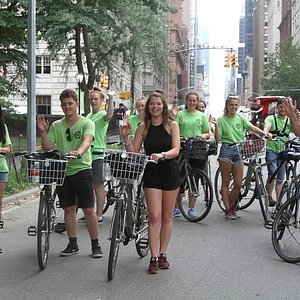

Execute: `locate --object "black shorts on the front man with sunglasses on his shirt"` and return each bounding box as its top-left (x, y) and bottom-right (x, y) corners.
top-left (56, 169), bottom-right (94, 208)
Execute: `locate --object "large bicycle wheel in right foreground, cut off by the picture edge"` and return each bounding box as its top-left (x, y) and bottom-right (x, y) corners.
top-left (272, 196), bottom-right (300, 263)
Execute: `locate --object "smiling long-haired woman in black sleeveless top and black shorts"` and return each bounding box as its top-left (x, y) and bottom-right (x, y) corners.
top-left (121, 92), bottom-right (180, 274)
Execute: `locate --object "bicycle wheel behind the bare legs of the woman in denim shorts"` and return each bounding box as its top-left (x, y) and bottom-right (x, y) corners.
top-left (214, 164), bottom-right (256, 212)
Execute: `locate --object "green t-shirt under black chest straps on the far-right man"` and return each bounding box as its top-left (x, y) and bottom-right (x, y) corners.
top-left (265, 114), bottom-right (292, 153)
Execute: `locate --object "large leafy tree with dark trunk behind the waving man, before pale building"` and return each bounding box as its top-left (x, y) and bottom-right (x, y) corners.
top-left (37, 0), bottom-right (168, 113)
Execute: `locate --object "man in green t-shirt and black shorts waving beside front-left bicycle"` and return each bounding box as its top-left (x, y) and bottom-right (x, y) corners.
top-left (37, 89), bottom-right (103, 258)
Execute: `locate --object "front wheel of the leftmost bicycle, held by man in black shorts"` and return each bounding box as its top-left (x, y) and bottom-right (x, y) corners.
top-left (37, 192), bottom-right (50, 270)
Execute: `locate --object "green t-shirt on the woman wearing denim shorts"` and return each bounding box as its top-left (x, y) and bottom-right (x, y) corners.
top-left (218, 114), bottom-right (251, 144)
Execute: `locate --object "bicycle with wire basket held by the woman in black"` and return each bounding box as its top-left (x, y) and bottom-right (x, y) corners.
top-left (104, 150), bottom-right (153, 280)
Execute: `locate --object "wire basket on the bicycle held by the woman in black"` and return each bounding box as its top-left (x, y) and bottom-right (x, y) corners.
top-left (104, 150), bottom-right (147, 180)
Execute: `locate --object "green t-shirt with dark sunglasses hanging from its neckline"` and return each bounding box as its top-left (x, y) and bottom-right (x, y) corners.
top-left (48, 116), bottom-right (95, 176)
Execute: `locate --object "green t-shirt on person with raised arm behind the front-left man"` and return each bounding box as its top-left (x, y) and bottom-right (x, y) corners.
top-left (86, 110), bottom-right (109, 160)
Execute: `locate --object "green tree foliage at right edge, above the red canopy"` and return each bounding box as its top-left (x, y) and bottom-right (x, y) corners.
top-left (262, 40), bottom-right (300, 99)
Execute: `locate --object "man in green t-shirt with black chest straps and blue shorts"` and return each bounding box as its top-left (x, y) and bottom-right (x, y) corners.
top-left (264, 98), bottom-right (292, 206)
